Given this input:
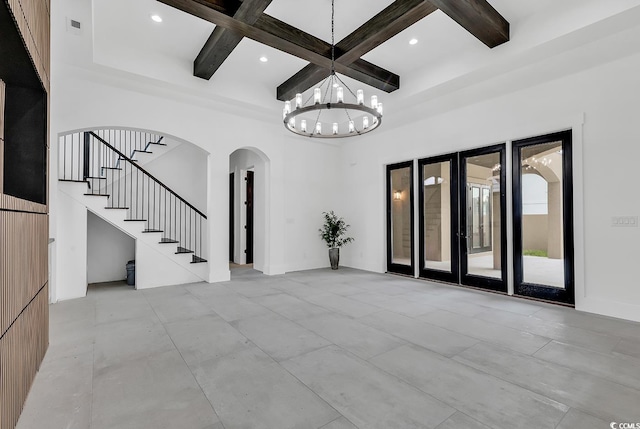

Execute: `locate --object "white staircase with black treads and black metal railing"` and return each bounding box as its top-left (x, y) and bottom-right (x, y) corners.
top-left (58, 130), bottom-right (207, 280)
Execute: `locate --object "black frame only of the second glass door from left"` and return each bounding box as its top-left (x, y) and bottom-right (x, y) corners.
top-left (418, 152), bottom-right (460, 283)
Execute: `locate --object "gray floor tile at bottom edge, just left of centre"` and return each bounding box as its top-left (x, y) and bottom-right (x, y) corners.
top-left (194, 346), bottom-right (339, 429)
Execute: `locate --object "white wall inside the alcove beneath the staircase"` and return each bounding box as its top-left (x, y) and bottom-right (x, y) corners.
top-left (87, 212), bottom-right (136, 283)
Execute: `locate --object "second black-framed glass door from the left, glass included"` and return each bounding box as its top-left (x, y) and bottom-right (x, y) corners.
top-left (418, 154), bottom-right (459, 283)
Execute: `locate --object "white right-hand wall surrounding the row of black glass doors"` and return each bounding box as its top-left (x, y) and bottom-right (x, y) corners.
top-left (341, 50), bottom-right (640, 320)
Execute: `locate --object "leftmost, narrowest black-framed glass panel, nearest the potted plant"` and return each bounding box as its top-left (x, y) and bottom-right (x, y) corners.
top-left (387, 161), bottom-right (414, 275)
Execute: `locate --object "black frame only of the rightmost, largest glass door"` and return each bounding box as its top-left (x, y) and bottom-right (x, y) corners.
top-left (512, 130), bottom-right (575, 305)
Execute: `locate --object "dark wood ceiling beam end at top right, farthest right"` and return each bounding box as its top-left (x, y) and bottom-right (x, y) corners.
top-left (428, 0), bottom-right (509, 48)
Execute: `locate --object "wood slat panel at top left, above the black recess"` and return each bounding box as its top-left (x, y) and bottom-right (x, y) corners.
top-left (8, 0), bottom-right (51, 92)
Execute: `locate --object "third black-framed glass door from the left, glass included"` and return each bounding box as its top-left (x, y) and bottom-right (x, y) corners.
top-left (459, 144), bottom-right (507, 292)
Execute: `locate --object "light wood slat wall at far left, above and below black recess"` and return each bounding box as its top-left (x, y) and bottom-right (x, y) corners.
top-left (0, 0), bottom-right (51, 429)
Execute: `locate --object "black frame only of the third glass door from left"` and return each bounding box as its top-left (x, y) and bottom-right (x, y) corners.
top-left (458, 143), bottom-right (507, 293)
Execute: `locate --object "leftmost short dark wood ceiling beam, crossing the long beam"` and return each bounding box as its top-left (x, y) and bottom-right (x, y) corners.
top-left (193, 0), bottom-right (273, 79)
